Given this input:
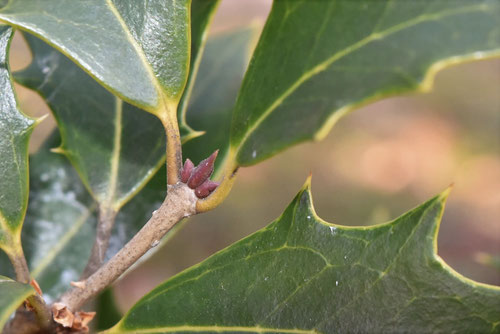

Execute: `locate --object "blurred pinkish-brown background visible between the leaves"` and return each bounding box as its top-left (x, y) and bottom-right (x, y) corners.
top-left (7, 0), bottom-right (500, 310)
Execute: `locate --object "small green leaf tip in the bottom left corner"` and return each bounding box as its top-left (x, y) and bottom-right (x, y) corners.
top-left (0, 276), bottom-right (35, 331)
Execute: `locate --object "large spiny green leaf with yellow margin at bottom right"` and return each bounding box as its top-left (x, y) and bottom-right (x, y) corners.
top-left (107, 184), bottom-right (500, 333)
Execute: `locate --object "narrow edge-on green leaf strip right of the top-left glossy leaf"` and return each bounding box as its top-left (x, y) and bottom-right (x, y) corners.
top-left (177, 0), bottom-right (220, 142)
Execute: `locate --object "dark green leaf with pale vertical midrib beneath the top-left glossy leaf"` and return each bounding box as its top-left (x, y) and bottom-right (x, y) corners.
top-left (15, 34), bottom-right (165, 211)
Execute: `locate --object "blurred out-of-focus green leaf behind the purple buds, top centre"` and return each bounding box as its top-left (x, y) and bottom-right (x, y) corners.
top-left (183, 28), bottom-right (256, 172)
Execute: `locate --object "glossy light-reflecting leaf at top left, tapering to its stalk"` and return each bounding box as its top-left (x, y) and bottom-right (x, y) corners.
top-left (0, 0), bottom-right (190, 118)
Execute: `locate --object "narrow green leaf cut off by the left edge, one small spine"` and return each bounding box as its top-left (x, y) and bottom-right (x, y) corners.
top-left (0, 25), bottom-right (35, 257)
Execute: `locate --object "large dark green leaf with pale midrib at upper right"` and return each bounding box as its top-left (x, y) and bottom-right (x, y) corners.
top-left (231, 0), bottom-right (500, 166)
